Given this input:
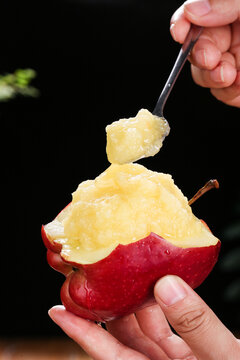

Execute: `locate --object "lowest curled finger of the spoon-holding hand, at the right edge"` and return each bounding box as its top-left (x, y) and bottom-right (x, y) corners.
top-left (211, 71), bottom-right (240, 107)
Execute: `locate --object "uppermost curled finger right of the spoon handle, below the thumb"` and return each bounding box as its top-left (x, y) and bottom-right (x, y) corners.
top-left (189, 26), bottom-right (231, 70)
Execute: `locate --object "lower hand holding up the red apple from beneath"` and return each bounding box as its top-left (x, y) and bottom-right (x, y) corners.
top-left (49, 275), bottom-right (240, 360)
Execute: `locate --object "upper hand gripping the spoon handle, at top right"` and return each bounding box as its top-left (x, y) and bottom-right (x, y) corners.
top-left (170, 0), bottom-right (240, 107)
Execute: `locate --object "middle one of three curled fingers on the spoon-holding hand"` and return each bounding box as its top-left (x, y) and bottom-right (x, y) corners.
top-left (191, 52), bottom-right (237, 89)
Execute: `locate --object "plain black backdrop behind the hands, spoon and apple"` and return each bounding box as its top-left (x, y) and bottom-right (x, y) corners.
top-left (0, 0), bottom-right (240, 336)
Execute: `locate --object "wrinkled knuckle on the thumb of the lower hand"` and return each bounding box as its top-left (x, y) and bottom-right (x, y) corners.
top-left (176, 308), bottom-right (208, 334)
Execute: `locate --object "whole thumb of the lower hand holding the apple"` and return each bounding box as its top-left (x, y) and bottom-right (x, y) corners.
top-left (154, 276), bottom-right (240, 360)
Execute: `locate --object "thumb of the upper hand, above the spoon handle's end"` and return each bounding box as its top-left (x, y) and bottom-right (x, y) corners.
top-left (184, 0), bottom-right (240, 27)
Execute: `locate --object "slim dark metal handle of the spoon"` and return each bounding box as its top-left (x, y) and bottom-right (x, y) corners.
top-left (153, 24), bottom-right (202, 117)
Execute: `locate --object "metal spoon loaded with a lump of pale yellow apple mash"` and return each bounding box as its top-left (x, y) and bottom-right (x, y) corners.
top-left (106, 25), bottom-right (202, 164)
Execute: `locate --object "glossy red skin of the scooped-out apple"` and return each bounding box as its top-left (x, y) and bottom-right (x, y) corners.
top-left (42, 226), bottom-right (221, 322)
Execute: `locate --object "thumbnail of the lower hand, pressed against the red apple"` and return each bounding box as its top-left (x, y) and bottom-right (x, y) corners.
top-left (155, 276), bottom-right (187, 306)
